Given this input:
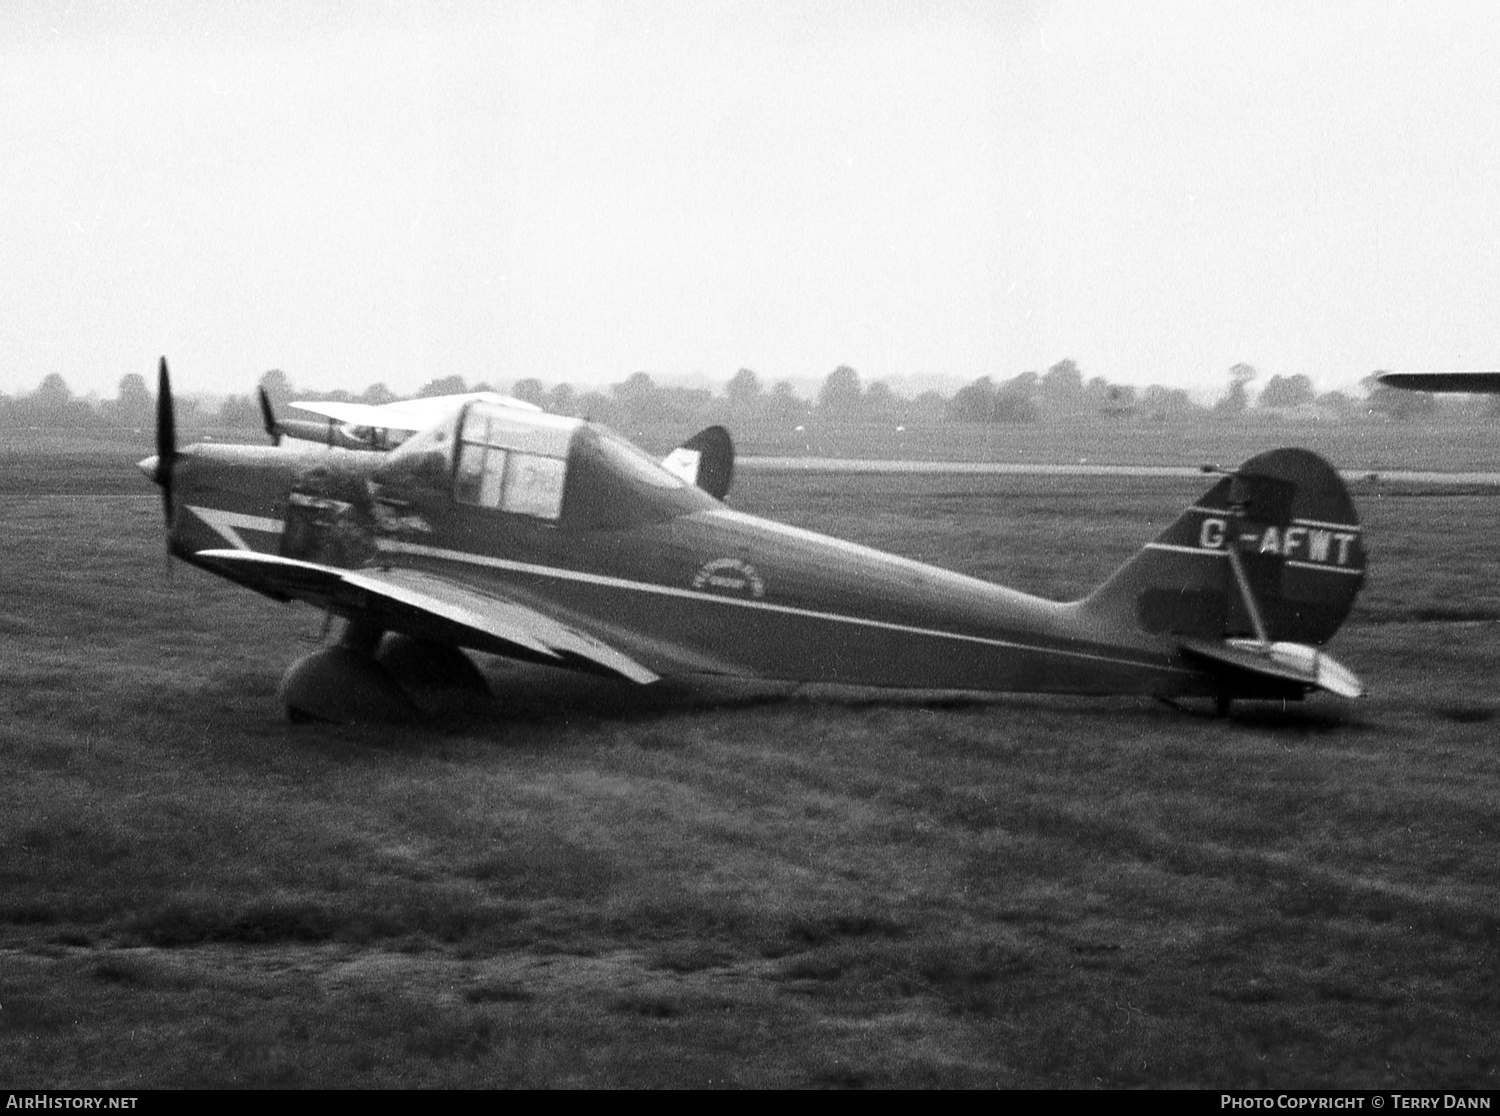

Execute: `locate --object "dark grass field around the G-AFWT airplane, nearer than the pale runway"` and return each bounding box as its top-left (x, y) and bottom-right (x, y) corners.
top-left (0, 440), bottom-right (1500, 1089)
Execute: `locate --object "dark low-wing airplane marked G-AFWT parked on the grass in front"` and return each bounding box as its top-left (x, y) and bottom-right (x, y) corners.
top-left (140, 359), bottom-right (1365, 723)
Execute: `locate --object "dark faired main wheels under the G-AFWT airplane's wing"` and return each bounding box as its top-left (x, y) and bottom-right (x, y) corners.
top-left (278, 623), bottom-right (489, 725)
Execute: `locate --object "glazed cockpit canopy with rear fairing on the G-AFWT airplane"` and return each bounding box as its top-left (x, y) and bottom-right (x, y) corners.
top-left (377, 401), bottom-right (714, 530)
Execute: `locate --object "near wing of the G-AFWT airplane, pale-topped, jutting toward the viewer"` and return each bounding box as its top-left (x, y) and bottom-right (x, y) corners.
top-left (194, 549), bottom-right (659, 684)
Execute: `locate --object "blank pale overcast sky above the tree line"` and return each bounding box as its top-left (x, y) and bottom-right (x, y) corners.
top-left (0, 0), bottom-right (1500, 396)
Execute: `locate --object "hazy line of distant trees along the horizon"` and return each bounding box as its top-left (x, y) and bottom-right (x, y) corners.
top-left (0, 360), bottom-right (1500, 431)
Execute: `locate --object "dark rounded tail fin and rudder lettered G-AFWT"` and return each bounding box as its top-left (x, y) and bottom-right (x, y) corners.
top-left (1083, 450), bottom-right (1365, 645)
